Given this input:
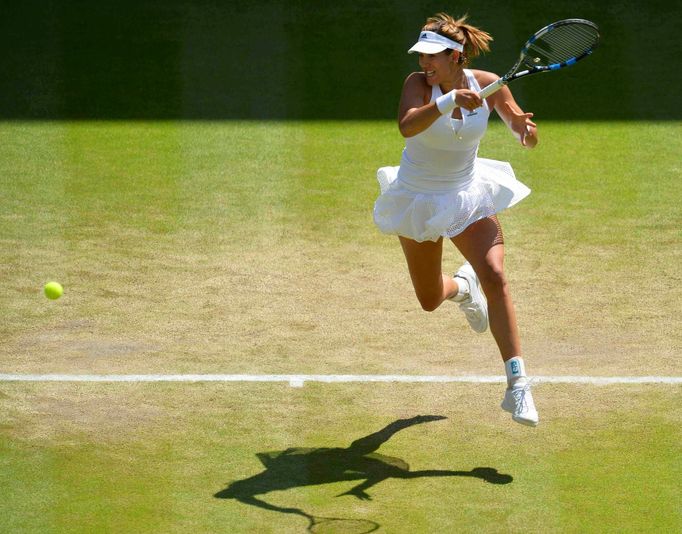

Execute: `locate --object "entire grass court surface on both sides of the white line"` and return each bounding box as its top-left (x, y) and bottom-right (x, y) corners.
top-left (0, 122), bottom-right (682, 533)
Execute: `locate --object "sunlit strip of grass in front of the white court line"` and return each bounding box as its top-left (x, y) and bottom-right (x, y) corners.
top-left (0, 384), bottom-right (682, 533)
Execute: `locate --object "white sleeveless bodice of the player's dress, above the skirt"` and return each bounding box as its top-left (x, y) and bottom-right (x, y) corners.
top-left (397, 69), bottom-right (490, 193)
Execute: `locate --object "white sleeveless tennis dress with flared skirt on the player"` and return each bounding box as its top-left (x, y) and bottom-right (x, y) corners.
top-left (374, 69), bottom-right (530, 241)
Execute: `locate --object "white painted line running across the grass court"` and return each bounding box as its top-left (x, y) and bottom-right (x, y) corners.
top-left (0, 373), bottom-right (682, 387)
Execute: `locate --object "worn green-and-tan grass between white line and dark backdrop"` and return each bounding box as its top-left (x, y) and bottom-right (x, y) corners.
top-left (0, 122), bottom-right (682, 375)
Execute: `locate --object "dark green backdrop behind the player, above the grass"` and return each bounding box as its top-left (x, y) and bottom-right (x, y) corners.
top-left (0, 0), bottom-right (682, 120)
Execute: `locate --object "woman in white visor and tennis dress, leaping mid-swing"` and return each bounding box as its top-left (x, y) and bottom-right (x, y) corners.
top-left (374, 13), bottom-right (538, 426)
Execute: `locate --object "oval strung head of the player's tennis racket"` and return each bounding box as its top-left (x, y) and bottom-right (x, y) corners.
top-left (527, 24), bottom-right (599, 65)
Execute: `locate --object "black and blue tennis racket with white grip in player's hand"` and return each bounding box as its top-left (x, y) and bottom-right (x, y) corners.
top-left (479, 19), bottom-right (599, 98)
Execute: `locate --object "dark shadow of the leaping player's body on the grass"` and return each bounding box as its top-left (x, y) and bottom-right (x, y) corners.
top-left (214, 415), bottom-right (514, 528)
